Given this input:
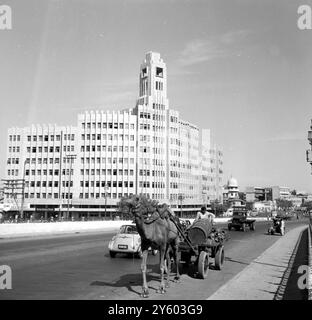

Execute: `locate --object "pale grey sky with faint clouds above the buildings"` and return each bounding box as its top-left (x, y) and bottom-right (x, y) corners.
top-left (0, 0), bottom-right (312, 192)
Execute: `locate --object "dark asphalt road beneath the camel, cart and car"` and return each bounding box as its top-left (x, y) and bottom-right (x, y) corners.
top-left (0, 221), bottom-right (307, 300)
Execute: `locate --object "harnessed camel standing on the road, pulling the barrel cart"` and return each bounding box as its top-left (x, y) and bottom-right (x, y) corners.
top-left (123, 196), bottom-right (180, 298)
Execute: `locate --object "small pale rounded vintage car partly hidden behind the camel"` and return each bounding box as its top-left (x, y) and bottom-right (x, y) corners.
top-left (108, 224), bottom-right (157, 258)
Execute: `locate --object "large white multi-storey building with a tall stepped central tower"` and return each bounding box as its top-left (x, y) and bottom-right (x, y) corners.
top-left (6, 52), bottom-right (222, 216)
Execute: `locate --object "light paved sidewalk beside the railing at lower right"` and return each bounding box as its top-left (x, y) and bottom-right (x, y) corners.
top-left (208, 226), bottom-right (307, 300)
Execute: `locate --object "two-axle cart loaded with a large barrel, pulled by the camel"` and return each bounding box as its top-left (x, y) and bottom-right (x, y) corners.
top-left (179, 219), bottom-right (226, 279)
